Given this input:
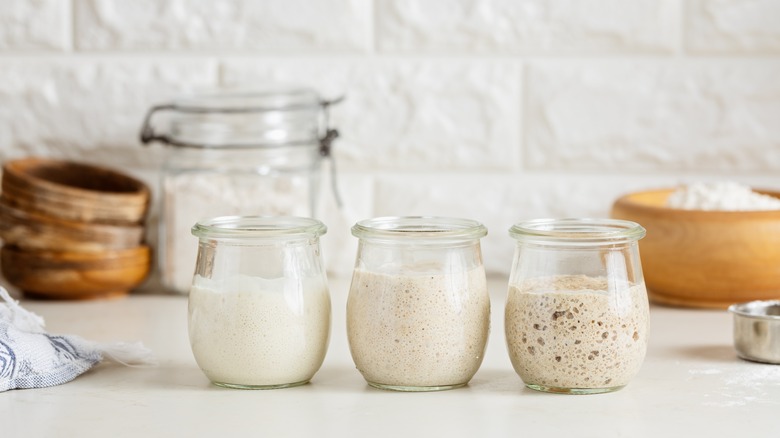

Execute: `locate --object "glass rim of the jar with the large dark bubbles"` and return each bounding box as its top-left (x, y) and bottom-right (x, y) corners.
top-left (509, 218), bottom-right (647, 244)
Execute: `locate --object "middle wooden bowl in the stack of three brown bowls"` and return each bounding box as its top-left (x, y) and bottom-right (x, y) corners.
top-left (0, 199), bottom-right (144, 252)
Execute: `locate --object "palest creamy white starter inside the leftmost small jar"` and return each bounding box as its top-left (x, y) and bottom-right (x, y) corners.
top-left (189, 276), bottom-right (330, 386)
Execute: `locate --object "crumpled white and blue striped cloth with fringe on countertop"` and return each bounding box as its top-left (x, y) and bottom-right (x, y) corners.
top-left (0, 287), bottom-right (153, 392)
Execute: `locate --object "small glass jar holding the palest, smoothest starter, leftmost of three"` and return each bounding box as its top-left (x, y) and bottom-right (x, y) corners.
top-left (189, 216), bottom-right (330, 389)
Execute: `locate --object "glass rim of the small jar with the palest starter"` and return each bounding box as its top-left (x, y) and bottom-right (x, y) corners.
top-left (192, 216), bottom-right (328, 239)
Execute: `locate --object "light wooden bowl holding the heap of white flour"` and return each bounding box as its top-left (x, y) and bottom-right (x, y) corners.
top-left (612, 189), bottom-right (780, 309)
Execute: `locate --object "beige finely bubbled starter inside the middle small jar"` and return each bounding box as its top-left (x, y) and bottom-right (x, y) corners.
top-left (347, 268), bottom-right (490, 388)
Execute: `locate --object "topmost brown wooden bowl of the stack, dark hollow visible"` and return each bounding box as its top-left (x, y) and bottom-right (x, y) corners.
top-left (2, 158), bottom-right (149, 224)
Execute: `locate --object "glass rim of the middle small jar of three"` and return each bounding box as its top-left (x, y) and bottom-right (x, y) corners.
top-left (352, 216), bottom-right (487, 241)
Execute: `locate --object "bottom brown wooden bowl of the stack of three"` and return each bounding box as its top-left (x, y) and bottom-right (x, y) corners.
top-left (0, 245), bottom-right (151, 299)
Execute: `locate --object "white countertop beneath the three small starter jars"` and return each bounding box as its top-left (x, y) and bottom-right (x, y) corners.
top-left (0, 278), bottom-right (780, 438)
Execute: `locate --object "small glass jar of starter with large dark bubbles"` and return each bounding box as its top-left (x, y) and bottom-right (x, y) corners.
top-left (504, 219), bottom-right (649, 394)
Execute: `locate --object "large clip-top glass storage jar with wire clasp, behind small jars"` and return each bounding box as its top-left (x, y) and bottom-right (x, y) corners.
top-left (141, 88), bottom-right (338, 293)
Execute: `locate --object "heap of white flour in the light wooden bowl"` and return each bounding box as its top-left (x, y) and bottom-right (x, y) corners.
top-left (666, 182), bottom-right (780, 211)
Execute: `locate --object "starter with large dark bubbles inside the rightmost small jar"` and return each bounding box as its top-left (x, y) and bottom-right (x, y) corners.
top-left (505, 276), bottom-right (648, 389)
